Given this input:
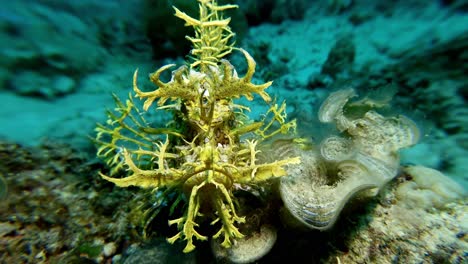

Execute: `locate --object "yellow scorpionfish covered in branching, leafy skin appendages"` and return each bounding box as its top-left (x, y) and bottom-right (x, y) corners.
top-left (95, 0), bottom-right (300, 252)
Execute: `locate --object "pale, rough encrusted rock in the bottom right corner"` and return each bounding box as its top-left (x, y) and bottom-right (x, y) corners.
top-left (327, 167), bottom-right (468, 263)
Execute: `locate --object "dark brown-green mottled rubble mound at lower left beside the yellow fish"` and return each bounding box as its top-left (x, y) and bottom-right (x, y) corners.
top-left (0, 142), bottom-right (135, 263)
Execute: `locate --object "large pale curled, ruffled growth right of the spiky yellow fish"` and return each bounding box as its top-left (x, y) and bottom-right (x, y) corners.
top-left (275, 89), bottom-right (419, 230)
